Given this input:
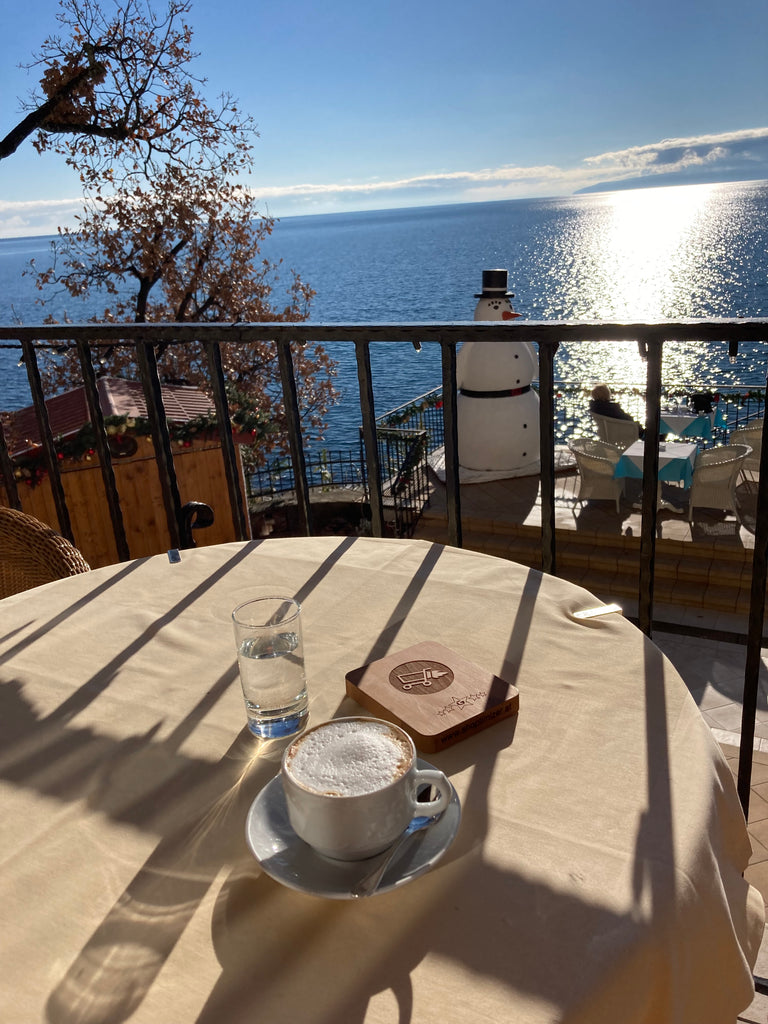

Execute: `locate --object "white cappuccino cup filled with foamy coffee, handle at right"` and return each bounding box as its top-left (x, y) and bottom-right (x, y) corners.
top-left (281, 718), bottom-right (452, 860)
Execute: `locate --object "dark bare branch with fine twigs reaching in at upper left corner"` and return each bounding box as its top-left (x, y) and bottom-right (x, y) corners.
top-left (0, 0), bottom-right (247, 172)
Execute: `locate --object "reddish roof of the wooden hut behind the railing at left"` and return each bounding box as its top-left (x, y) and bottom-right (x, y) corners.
top-left (8, 377), bottom-right (215, 456)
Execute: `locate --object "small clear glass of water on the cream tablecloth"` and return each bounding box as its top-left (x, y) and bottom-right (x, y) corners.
top-left (232, 597), bottom-right (308, 737)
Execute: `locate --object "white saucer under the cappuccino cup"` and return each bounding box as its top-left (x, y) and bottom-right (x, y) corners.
top-left (246, 758), bottom-right (461, 899)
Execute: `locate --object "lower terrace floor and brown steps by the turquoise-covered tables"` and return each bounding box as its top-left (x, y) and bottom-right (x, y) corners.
top-left (414, 450), bottom-right (757, 633)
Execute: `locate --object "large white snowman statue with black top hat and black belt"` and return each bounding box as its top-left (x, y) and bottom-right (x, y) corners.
top-left (457, 270), bottom-right (541, 478)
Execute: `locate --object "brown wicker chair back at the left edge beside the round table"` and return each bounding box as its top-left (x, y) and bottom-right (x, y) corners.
top-left (0, 507), bottom-right (90, 598)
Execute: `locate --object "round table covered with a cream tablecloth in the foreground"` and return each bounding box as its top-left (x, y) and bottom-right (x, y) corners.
top-left (0, 538), bottom-right (763, 1024)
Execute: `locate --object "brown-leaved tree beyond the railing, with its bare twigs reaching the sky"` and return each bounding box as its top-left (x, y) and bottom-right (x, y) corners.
top-left (12, 0), bottom-right (335, 454)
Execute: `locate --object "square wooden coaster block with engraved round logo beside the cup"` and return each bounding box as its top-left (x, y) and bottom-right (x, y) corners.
top-left (346, 640), bottom-right (520, 754)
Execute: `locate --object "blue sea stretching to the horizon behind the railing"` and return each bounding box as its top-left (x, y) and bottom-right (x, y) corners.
top-left (0, 181), bottom-right (768, 450)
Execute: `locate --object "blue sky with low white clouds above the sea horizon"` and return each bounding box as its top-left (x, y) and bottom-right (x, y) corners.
top-left (0, 0), bottom-right (768, 237)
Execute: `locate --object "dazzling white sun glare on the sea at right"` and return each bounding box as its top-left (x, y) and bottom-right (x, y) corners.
top-left (538, 184), bottom-right (765, 389)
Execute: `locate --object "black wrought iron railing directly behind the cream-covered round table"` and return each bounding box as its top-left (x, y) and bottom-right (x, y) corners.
top-left (0, 319), bottom-right (768, 823)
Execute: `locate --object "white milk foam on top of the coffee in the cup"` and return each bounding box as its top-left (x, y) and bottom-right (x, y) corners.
top-left (286, 721), bottom-right (412, 797)
